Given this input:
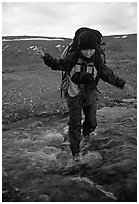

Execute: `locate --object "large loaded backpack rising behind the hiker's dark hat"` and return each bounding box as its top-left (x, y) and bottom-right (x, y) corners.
top-left (60, 27), bottom-right (106, 98)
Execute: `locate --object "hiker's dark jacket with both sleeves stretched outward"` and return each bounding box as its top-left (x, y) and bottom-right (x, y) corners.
top-left (42, 49), bottom-right (125, 97)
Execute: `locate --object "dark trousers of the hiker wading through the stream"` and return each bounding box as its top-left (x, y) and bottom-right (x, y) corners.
top-left (67, 91), bottom-right (97, 156)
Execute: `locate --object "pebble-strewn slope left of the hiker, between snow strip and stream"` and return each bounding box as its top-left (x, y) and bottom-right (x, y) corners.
top-left (3, 37), bottom-right (70, 123)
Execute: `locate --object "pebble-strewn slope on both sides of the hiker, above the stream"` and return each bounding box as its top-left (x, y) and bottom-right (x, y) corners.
top-left (2, 35), bottom-right (137, 123)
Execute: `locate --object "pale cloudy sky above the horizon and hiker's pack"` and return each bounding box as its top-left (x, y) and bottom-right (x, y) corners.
top-left (2, 2), bottom-right (137, 38)
